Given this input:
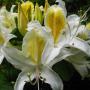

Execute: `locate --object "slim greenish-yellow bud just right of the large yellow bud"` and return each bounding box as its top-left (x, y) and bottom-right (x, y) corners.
top-left (35, 3), bottom-right (43, 24)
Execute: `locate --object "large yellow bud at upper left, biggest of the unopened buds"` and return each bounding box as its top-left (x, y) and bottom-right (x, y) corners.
top-left (18, 1), bottom-right (34, 35)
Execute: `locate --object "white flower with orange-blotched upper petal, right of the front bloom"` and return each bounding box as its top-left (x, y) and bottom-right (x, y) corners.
top-left (45, 5), bottom-right (90, 66)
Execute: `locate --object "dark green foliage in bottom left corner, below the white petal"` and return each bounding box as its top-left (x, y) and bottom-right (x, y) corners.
top-left (0, 59), bottom-right (19, 90)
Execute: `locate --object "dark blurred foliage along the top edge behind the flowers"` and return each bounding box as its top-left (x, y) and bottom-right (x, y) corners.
top-left (0, 0), bottom-right (90, 22)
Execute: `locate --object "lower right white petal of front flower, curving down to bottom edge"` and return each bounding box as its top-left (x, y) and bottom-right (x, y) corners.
top-left (41, 67), bottom-right (63, 90)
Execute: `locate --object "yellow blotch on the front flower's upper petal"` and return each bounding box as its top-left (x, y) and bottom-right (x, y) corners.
top-left (23, 30), bottom-right (46, 64)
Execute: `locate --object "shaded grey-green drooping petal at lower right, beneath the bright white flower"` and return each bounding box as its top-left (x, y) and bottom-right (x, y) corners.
top-left (67, 51), bottom-right (89, 78)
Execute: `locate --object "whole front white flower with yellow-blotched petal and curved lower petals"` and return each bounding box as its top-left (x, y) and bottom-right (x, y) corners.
top-left (2, 21), bottom-right (63, 90)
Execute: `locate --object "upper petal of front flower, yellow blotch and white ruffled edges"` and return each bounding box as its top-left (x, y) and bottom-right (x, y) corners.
top-left (22, 22), bottom-right (54, 63)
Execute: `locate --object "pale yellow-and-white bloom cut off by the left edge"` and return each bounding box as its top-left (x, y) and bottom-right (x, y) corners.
top-left (0, 6), bottom-right (16, 64)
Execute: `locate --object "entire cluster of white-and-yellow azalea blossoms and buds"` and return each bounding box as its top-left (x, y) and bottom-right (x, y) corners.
top-left (0, 0), bottom-right (90, 90)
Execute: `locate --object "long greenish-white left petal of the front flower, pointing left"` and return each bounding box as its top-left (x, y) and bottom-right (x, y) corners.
top-left (2, 47), bottom-right (34, 71)
